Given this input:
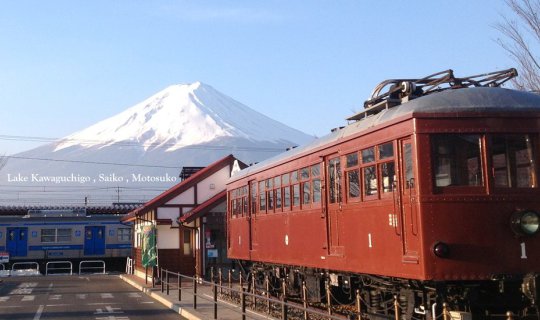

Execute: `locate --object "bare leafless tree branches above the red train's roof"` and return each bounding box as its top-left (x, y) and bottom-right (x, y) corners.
top-left (495, 0), bottom-right (540, 92)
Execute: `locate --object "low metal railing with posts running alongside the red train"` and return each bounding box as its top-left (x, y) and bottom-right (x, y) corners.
top-left (159, 268), bottom-right (344, 320)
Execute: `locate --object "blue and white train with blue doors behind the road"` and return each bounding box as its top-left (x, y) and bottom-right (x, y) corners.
top-left (0, 208), bottom-right (132, 263)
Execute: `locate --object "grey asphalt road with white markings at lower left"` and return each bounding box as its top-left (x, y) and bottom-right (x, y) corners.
top-left (0, 275), bottom-right (184, 320)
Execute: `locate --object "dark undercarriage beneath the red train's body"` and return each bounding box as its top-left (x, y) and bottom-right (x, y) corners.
top-left (241, 262), bottom-right (540, 320)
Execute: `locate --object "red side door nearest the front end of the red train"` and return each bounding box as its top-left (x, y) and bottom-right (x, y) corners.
top-left (399, 138), bottom-right (420, 263)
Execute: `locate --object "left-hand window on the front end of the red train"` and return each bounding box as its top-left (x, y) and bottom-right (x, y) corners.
top-left (431, 134), bottom-right (484, 187)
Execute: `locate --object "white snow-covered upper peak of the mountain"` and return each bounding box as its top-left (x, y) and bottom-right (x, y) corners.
top-left (54, 82), bottom-right (311, 151)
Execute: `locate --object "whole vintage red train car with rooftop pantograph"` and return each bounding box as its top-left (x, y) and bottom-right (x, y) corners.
top-left (227, 69), bottom-right (540, 319)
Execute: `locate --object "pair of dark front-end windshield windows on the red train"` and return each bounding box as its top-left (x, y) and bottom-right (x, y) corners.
top-left (431, 134), bottom-right (538, 188)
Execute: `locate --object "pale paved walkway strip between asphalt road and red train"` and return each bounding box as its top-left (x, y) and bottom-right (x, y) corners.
top-left (120, 274), bottom-right (275, 320)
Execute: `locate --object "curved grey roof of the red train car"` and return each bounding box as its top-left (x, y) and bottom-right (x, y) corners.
top-left (229, 87), bottom-right (540, 183)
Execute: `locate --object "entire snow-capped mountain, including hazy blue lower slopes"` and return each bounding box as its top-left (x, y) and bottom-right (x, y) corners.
top-left (0, 82), bottom-right (314, 205)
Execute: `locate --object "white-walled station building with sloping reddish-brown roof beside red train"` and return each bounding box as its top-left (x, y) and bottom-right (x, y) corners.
top-left (123, 155), bottom-right (246, 279)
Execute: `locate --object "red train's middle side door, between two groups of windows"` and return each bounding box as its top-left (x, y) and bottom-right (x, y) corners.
top-left (325, 154), bottom-right (343, 255)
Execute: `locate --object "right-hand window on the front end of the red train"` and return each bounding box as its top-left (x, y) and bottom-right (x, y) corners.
top-left (490, 134), bottom-right (537, 188)
